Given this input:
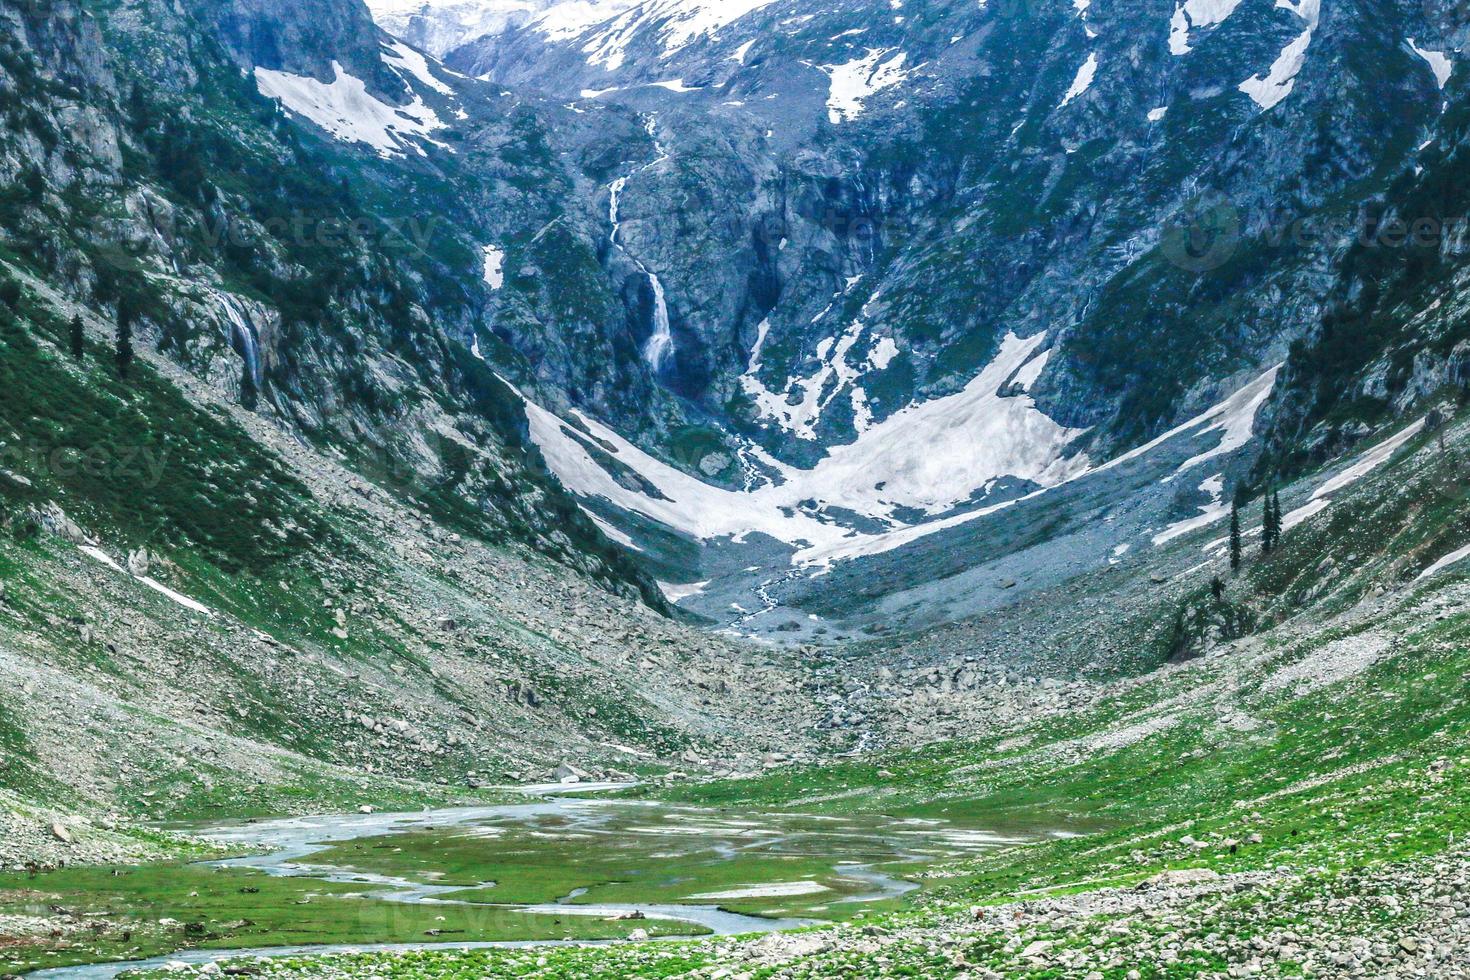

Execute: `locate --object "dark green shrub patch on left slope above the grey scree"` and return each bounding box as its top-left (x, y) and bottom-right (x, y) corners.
top-left (0, 283), bottom-right (327, 574)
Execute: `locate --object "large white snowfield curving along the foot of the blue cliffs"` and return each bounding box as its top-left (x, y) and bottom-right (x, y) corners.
top-left (526, 334), bottom-right (1276, 575)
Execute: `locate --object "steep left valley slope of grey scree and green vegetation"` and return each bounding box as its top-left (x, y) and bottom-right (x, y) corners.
top-left (0, 3), bottom-right (840, 834)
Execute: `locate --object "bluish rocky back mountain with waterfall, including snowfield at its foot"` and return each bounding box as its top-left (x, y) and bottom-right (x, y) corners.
top-left (352, 1), bottom-right (1466, 641)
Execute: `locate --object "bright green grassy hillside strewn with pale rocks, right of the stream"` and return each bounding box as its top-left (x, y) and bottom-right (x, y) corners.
top-left (111, 405), bottom-right (1470, 980)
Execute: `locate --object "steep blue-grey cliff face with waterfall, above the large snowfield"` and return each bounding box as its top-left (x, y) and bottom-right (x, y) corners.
top-left (451, 3), bottom-right (1448, 464)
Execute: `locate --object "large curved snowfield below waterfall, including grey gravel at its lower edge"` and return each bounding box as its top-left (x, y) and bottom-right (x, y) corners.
top-left (511, 334), bottom-right (1277, 639)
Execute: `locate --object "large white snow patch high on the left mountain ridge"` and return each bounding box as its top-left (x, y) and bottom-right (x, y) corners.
top-left (256, 62), bottom-right (445, 157)
